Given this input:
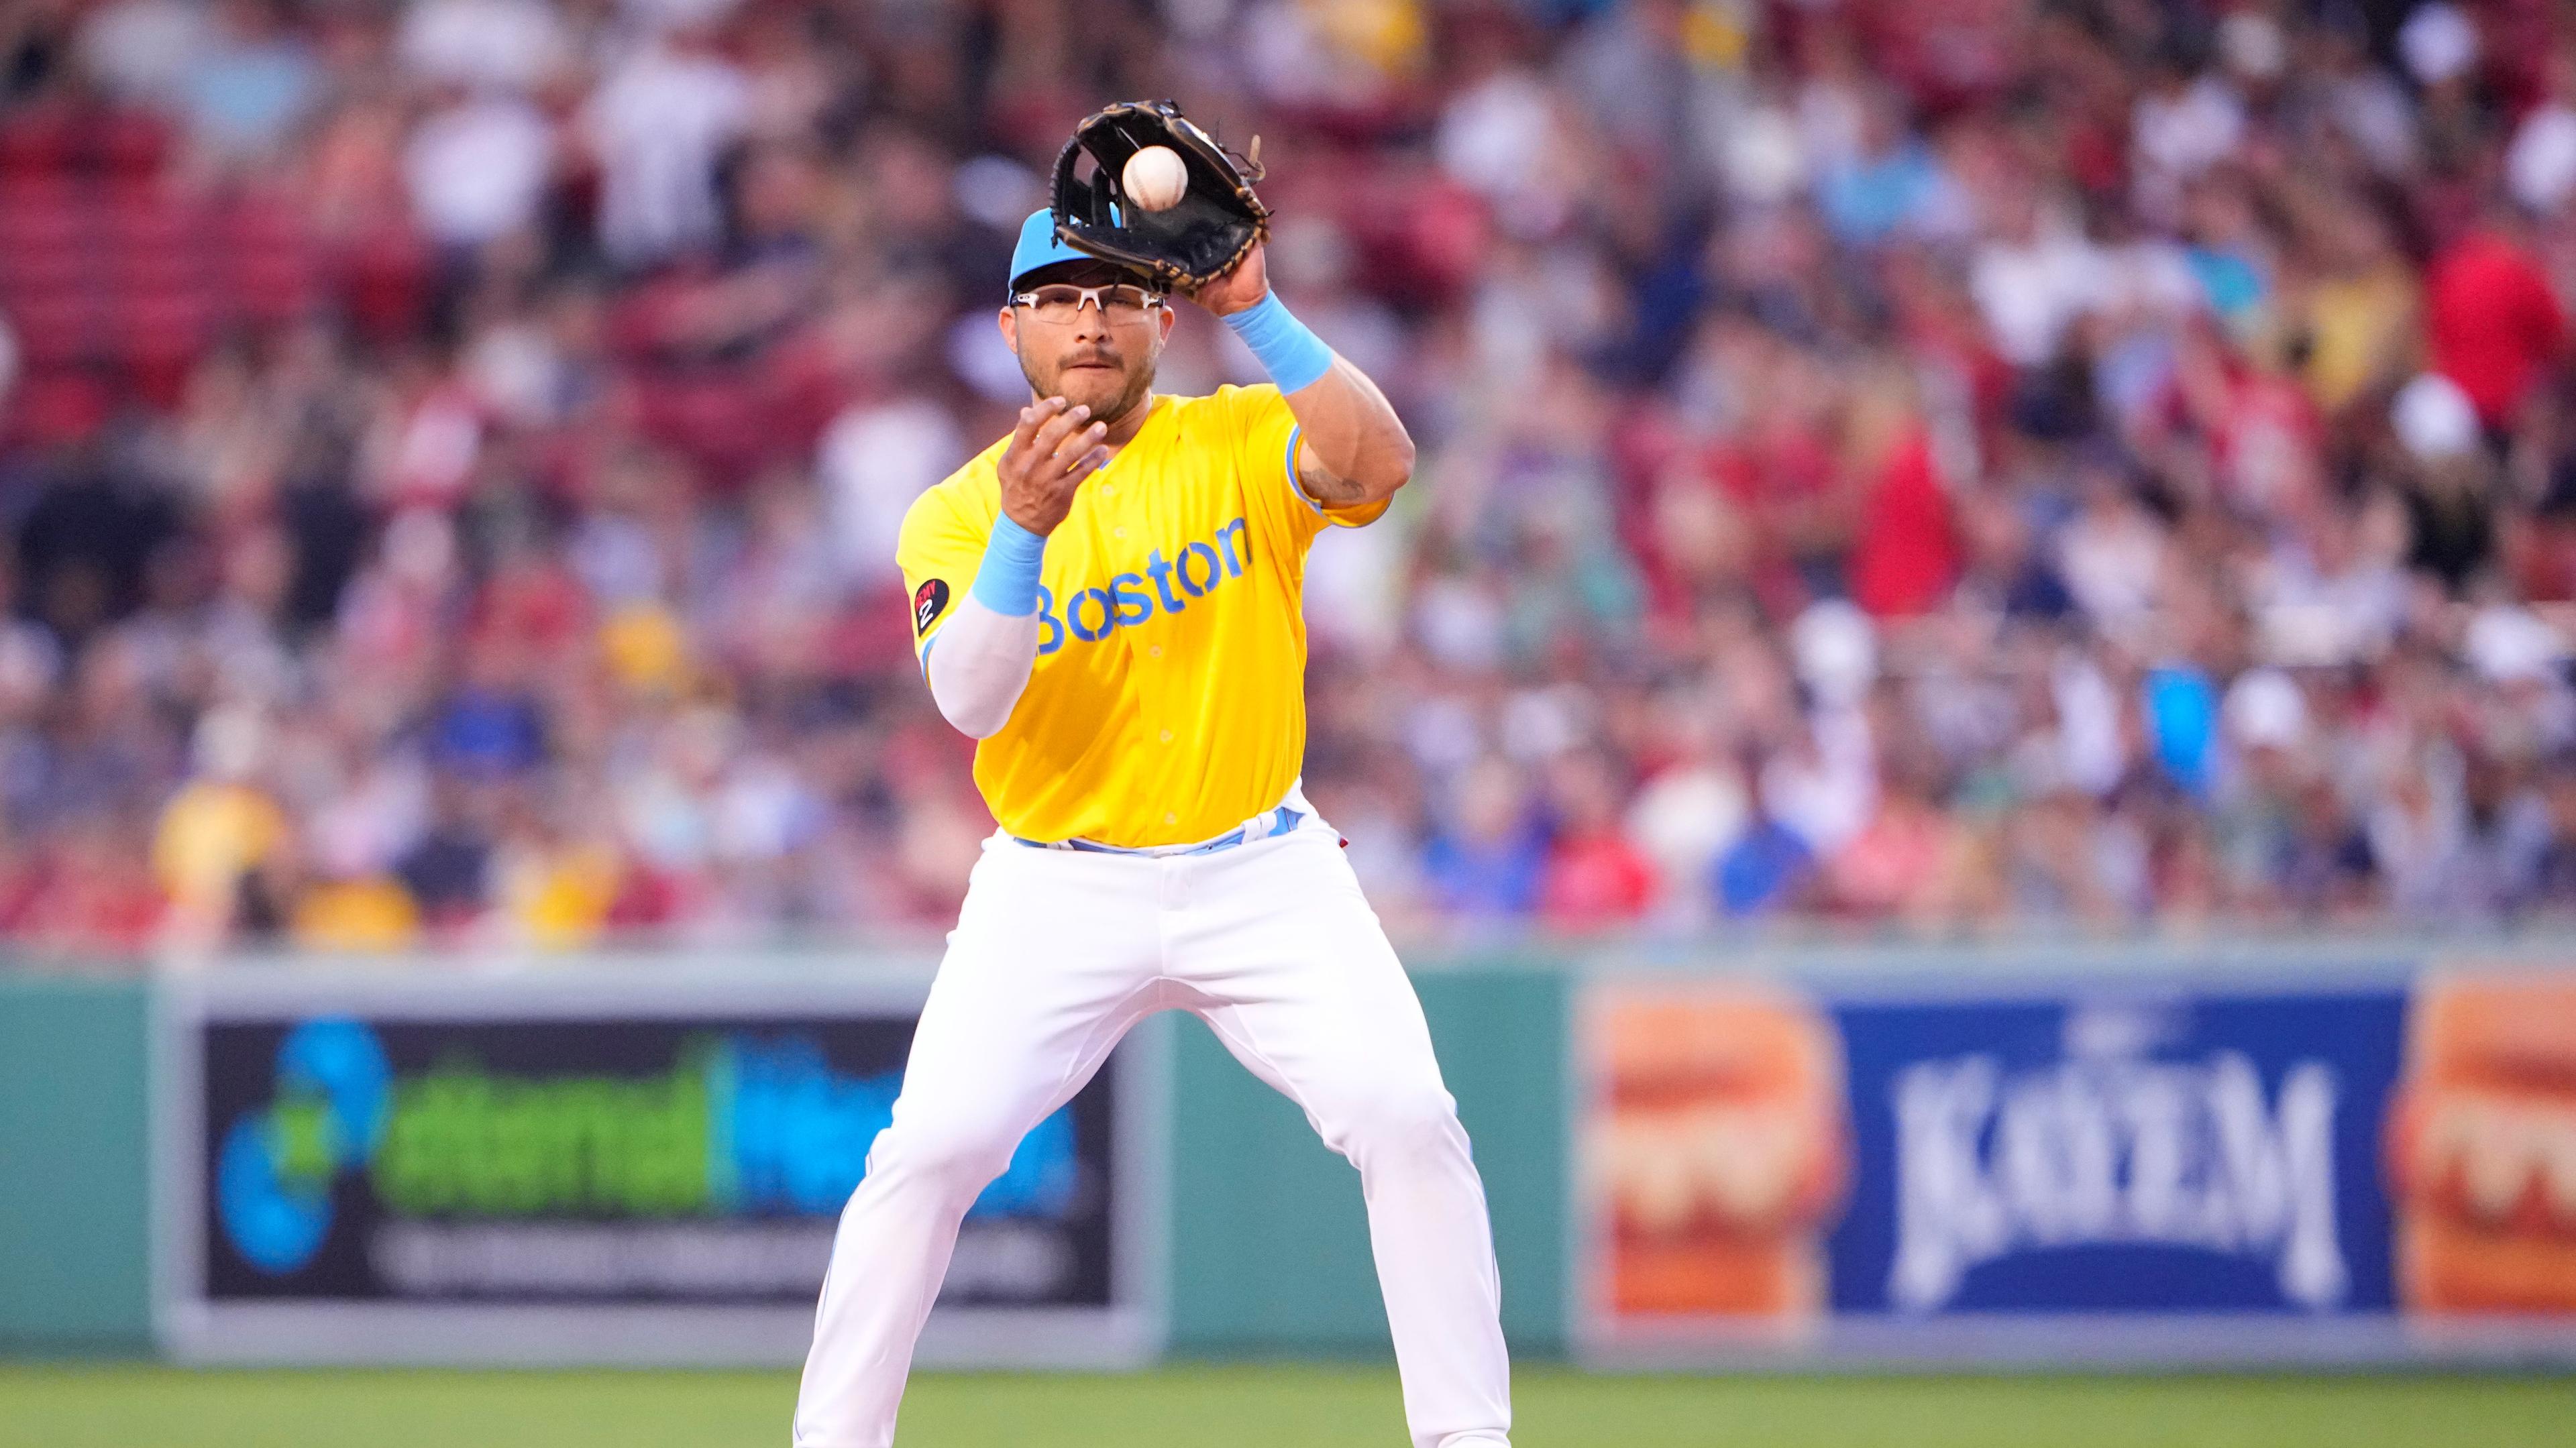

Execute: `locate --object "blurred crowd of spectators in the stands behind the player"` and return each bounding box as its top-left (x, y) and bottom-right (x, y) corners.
top-left (0, 0), bottom-right (2576, 956)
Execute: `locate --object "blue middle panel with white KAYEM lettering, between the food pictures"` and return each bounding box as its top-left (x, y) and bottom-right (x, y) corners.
top-left (1827, 989), bottom-right (2406, 1314)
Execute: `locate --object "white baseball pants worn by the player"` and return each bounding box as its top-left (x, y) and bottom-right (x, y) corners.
top-left (796, 796), bottom-right (1512, 1448)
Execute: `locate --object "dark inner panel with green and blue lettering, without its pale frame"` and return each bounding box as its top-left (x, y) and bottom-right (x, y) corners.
top-left (201, 1013), bottom-right (1087, 1306)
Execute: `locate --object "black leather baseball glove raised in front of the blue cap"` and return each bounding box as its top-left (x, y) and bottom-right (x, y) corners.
top-left (1051, 101), bottom-right (1270, 291)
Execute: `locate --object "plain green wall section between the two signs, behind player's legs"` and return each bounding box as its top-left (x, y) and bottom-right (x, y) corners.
top-left (1172, 966), bottom-right (1566, 1358)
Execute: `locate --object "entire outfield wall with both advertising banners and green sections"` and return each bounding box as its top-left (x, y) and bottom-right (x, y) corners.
top-left (0, 943), bottom-right (2576, 1368)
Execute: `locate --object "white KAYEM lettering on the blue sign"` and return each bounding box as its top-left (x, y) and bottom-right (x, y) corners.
top-left (1888, 1051), bottom-right (2352, 1311)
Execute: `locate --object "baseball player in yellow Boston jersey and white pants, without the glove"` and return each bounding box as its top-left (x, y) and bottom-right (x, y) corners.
top-left (796, 211), bottom-right (1512, 1448)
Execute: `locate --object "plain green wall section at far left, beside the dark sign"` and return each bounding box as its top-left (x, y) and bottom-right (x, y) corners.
top-left (0, 974), bottom-right (152, 1355)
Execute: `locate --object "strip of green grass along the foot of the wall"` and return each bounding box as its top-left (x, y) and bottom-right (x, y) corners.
top-left (0, 1366), bottom-right (2576, 1448)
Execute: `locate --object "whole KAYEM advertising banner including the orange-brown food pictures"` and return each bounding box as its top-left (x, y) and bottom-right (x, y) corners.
top-left (1571, 971), bottom-right (2576, 1366)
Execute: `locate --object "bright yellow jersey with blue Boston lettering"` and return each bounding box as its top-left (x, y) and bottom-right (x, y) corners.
top-left (896, 386), bottom-right (1386, 848)
